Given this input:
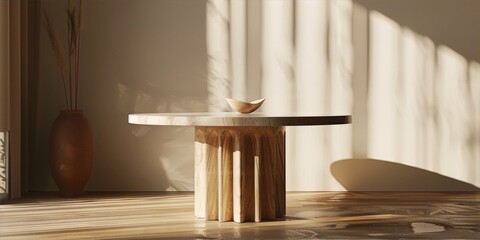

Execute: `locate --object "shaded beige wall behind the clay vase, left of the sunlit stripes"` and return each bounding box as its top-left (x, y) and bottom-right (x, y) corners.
top-left (30, 0), bottom-right (207, 190)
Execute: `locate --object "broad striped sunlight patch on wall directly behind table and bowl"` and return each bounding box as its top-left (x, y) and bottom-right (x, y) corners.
top-left (207, 0), bottom-right (353, 190)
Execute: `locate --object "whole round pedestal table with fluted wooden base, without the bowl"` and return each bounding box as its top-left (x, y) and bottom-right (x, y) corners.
top-left (128, 112), bottom-right (351, 222)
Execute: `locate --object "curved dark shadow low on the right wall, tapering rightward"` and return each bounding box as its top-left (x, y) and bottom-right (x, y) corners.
top-left (330, 159), bottom-right (480, 191)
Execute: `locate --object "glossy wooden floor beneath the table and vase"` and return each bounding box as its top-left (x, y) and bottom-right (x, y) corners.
top-left (0, 192), bottom-right (480, 239)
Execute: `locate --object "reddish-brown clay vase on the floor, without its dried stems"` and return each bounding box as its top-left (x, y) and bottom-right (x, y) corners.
top-left (50, 110), bottom-right (93, 197)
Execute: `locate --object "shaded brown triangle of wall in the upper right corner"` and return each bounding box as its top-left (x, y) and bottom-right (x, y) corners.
top-left (353, 0), bottom-right (480, 62)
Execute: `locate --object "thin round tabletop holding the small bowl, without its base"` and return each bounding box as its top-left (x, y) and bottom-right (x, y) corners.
top-left (128, 112), bottom-right (352, 127)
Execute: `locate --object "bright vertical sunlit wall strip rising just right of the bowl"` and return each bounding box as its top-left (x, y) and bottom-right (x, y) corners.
top-left (262, 0), bottom-right (295, 114)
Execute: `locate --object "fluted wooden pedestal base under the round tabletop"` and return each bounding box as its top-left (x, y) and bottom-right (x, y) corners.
top-left (195, 126), bottom-right (286, 222)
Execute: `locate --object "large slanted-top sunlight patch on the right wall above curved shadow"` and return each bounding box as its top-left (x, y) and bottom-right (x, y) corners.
top-left (368, 12), bottom-right (480, 185)
